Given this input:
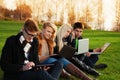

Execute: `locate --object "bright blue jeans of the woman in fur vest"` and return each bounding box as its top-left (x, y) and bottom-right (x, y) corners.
top-left (43, 57), bottom-right (70, 68)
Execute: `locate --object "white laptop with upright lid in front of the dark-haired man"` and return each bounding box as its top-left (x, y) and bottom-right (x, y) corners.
top-left (75, 38), bottom-right (89, 55)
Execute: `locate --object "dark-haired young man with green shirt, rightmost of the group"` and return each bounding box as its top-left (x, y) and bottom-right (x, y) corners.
top-left (70, 22), bottom-right (107, 68)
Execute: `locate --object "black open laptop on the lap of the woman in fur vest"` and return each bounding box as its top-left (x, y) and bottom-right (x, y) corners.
top-left (51, 45), bottom-right (76, 59)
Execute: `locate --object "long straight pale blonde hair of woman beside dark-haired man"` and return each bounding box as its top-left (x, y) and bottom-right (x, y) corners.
top-left (57, 24), bottom-right (72, 51)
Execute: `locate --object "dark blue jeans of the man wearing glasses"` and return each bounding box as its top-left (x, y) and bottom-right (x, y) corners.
top-left (19, 61), bottom-right (63, 80)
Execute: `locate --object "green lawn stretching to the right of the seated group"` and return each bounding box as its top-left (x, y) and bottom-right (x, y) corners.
top-left (84, 30), bottom-right (120, 80)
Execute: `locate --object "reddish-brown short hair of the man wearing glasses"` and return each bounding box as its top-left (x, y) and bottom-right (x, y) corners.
top-left (23, 19), bottom-right (39, 32)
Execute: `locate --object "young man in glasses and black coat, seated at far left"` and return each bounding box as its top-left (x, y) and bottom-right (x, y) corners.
top-left (1, 19), bottom-right (62, 80)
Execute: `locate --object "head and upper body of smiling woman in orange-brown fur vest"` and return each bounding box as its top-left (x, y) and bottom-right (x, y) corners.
top-left (38, 22), bottom-right (57, 62)
